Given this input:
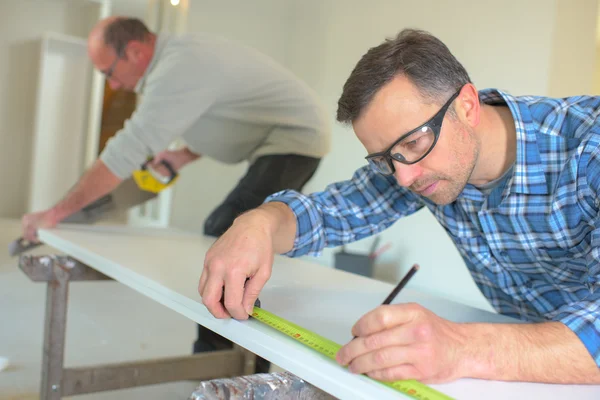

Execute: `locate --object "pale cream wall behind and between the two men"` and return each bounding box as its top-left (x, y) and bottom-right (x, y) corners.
top-left (168, 0), bottom-right (597, 309)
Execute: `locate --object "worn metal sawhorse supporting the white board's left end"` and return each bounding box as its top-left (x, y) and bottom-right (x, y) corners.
top-left (19, 255), bottom-right (256, 400)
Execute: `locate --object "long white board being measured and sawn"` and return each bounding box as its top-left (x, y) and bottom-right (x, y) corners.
top-left (40, 225), bottom-right (600, 400)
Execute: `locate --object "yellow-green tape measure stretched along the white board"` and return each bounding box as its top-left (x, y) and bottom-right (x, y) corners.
top-left (252, 307), bottom-right (452, 400)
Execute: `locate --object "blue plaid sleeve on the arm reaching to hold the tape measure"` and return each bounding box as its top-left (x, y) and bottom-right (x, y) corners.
top-left (265, 166), bottom-right (423, 257)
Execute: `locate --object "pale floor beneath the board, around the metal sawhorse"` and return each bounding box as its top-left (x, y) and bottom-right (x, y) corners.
top-left (0, 219), bottom-right (278, 400)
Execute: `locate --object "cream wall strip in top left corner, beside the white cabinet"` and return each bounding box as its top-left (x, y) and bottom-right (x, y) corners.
top-left (0, 0), bottom-right (97, 217)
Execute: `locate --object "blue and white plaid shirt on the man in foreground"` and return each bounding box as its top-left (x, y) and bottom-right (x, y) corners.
top-left (267, 89), bottom-right (600, 365)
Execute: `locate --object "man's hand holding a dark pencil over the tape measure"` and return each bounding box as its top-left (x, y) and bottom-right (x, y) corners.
top-left (336, 265), bottom-right (469, 383)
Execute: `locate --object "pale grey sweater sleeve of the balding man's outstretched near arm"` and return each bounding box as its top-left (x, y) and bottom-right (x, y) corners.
top-left (100, 50), bottom-right (221, 179)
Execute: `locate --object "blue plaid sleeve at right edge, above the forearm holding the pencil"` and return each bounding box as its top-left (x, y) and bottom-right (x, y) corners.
top-left (554, 145), bottom-right (600, 367)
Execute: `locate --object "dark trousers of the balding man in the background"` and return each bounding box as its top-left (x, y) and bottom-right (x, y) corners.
top-left (194, 154), bottom-right (321, 373)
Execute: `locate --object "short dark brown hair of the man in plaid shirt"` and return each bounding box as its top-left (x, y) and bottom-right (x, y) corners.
top-left (337, 29), bottom-right (471, 123)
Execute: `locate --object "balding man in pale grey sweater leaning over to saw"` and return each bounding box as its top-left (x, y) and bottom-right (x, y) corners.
top-left (22, 17), bottom-right (330, 372)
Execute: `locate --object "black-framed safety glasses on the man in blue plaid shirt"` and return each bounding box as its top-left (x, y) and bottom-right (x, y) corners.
top-left (365, 88), bottom-right (462, 176)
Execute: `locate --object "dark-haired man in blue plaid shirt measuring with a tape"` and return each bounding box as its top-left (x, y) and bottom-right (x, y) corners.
top-left (199, 30), bottom-right (600, 383)
